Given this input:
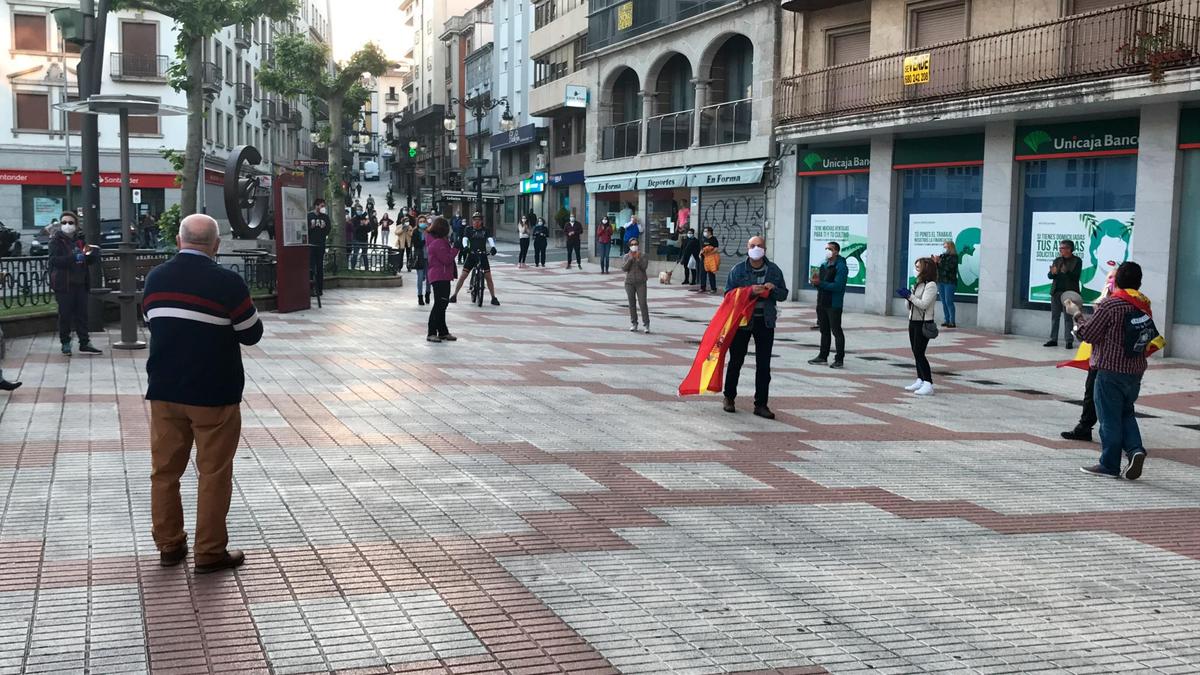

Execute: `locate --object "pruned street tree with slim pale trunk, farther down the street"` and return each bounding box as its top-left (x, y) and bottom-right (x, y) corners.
top-left (258, 35), bottom-right (391, 246)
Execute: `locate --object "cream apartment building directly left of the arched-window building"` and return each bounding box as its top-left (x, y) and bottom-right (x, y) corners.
top-left (529, 0), bottom-right (589, 234)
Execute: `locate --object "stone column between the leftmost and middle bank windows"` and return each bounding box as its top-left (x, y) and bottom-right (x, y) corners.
top-left (863, 135), bottom-right (896, 316)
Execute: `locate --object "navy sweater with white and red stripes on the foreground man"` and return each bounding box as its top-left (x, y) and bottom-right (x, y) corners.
top-left (142, 252), bottom-right (263, 406)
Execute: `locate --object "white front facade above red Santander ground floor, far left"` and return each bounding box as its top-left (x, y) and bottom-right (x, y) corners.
top-left (0, 2), bottom-right (186, 235)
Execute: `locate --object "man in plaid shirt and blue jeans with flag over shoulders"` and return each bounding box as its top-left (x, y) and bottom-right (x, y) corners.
top-left (1075, 262), bottom-right (1165, 480)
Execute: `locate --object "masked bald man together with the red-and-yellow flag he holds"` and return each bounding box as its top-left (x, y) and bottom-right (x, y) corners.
top-left (679, 237), bottom-right (787, 419)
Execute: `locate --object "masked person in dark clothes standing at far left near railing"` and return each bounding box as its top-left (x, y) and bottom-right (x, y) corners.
top-left (49, 211), bottom-right (100, 354)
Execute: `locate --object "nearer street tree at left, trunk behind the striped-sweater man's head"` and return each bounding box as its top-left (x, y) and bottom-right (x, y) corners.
top-left (113, 0), bottom-right (300, 216)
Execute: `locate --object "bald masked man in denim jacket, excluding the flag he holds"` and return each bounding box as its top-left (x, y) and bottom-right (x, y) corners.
top-left (722, 237), bottom-right (787, 419)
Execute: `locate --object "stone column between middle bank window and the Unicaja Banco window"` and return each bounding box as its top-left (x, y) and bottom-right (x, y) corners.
top-left (976, 120), bottom-right (1021, 333)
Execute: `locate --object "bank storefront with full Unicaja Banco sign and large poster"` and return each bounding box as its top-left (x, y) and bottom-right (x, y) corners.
top-left (1014, 118), bottom-right (1139, 309)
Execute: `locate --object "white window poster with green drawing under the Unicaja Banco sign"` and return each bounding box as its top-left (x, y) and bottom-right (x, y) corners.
top-left (1028, 211), bottom-right (1134, 303)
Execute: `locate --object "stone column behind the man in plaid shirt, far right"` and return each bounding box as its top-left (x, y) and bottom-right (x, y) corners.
top-left (1129, 102), bottom-right (1180, 345)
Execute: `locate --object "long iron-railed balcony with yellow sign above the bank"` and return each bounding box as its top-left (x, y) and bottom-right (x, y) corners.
top-left (775, 0), bottom-right (1200, 125)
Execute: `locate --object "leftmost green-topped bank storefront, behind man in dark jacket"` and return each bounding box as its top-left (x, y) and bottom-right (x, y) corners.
top-left (796, 145), bottom-right (871, 293)
